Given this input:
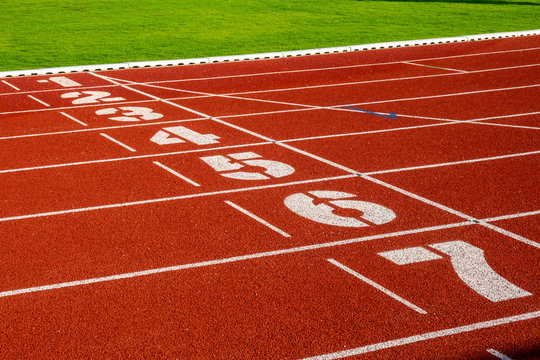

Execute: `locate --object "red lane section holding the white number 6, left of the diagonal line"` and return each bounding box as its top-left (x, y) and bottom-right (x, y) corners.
top-left (0, 175), bottom-right (463, 291)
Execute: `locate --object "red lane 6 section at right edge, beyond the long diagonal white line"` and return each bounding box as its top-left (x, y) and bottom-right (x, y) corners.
top-left (374, 154), bottom-right (540, 221)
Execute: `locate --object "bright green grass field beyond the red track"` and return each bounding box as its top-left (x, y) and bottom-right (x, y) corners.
top-left (0, 0), bottom-right (540, 71)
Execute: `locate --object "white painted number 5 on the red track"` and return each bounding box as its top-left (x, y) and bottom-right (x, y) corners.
top-left (201, 152), bottom-right (294, 180)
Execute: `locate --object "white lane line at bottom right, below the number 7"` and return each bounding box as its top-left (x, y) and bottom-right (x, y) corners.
top-left (304, 311), bottom-right (540, 360)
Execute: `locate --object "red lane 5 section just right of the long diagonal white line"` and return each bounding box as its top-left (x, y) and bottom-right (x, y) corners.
top-left (290, 120), bottom-right (540, 177)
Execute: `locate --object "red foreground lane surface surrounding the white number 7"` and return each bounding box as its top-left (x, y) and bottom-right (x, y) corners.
top-left (1, 226), bottom-right (539, 359)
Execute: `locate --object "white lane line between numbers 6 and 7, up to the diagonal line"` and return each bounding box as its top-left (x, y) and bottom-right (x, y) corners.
top-left (0, 222), bottom-right (474, 298)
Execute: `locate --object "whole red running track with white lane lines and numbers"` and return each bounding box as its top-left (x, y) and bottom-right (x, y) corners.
top-left (0, 36), bottom-right (540, 359)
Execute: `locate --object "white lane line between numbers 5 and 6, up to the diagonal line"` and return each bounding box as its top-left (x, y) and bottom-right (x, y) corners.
top-left (0, 174), bottom-right (356, 222)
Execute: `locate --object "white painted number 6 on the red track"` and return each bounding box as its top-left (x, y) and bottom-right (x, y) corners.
top-left (285, 191), bottom-right (396, 227)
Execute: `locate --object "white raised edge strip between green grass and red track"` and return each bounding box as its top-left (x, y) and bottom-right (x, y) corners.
top-left (0, 29), bottom-right (540, 78)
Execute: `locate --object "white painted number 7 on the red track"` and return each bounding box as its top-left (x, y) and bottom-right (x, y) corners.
top-left (378, 240), bottom-right (532, 302)
